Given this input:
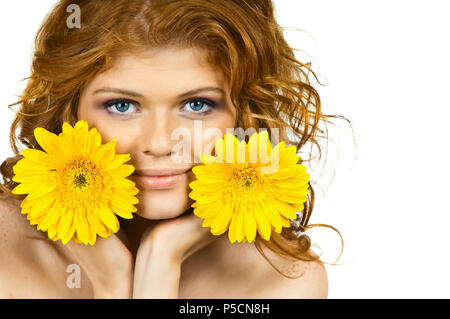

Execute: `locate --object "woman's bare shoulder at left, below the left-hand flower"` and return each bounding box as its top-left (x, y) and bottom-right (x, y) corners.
top-left (0, 193), bottom-right (92, 298)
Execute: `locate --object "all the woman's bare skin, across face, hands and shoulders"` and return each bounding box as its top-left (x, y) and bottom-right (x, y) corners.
top-left (0, 49), bottom-right (328, 298)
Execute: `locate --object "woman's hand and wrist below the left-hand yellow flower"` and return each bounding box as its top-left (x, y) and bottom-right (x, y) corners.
top-left (65, 234), bottom-right (134, 298)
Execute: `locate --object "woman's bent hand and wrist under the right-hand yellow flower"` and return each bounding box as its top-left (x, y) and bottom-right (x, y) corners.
top-left (133, 211), bottom-right (218, 298)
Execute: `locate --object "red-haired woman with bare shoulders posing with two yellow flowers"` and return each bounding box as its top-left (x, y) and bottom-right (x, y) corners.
top-left (0, 0), bottom-right (338, 298)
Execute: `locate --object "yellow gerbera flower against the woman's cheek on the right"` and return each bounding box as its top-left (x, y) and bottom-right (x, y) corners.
top-left (189, 130), bottom-right (309, 243)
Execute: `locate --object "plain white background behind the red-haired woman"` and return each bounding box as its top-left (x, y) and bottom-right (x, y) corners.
top-left (0, 0), bottom-right (450, 298)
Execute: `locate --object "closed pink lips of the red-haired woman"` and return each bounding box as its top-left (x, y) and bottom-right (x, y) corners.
top-left (132, 168), bottom-right (191, 189)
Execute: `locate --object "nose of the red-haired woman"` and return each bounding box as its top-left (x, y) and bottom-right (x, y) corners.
top-left (141, 107), bottom-right (175, 157)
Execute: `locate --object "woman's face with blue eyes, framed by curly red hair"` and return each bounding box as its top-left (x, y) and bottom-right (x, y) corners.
top-left (78, 49), bottom-right (236, 219)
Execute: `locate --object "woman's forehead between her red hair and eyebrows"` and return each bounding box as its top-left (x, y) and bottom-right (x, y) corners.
top-left (84, 48), bottom-right (225, 94)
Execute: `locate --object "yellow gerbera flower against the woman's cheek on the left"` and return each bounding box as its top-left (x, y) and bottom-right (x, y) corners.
top-left (12, 120), bottom-right (139, 245)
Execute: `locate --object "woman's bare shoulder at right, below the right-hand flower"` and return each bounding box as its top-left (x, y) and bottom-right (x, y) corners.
top-left (180, 236), bottom-right (328, 299)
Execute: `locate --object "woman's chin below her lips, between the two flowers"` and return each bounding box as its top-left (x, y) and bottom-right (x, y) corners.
top-left (132, 188), bottom-right (193, 219)
